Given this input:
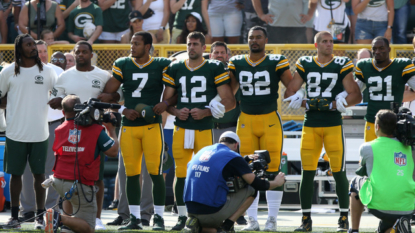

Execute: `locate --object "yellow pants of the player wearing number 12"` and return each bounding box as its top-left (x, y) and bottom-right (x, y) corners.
top-left (173, 126), bottom-right (213, 178)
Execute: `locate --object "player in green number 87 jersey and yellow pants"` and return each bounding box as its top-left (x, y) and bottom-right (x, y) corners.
top-left (285, 31), bottom-right (362, 231)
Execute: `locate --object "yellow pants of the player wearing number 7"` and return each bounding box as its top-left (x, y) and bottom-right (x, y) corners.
top-left (120, 123), bottom-right (164, 176)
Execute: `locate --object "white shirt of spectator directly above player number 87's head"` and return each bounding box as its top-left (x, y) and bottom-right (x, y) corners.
top-left (314, 1), bottom-right (350, 32)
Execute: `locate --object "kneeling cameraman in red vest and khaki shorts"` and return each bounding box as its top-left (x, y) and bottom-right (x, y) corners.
top-left (45, 95), bottom-right (118, 233)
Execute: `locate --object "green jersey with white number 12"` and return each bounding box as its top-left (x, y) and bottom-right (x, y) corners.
top-left (163, 59), bottom-right (230, 130)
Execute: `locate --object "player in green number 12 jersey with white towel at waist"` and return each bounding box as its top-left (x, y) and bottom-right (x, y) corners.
top-left (163, 32), bottom-right (235, 231)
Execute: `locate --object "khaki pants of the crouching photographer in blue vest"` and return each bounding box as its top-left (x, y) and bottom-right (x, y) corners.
top-left (188, 185), bottom-right (255, 228)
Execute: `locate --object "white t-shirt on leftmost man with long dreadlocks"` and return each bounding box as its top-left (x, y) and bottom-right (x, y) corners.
top-left (0, 63), bottom-right (57, 142)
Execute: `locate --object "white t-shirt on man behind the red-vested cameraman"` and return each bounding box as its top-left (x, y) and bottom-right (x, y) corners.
top-left (51, 66), bottom-right (111, 103)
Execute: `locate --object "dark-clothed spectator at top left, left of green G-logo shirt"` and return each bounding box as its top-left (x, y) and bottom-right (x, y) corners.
top-left (19, 0), bottom-right (65, 39)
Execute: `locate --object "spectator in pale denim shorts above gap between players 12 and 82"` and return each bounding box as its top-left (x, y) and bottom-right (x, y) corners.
top-left (208, 0), bottom-right (244, 44)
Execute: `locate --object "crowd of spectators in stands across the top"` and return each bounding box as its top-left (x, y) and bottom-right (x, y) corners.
top-left (0, 0), bottom-right (415, 45)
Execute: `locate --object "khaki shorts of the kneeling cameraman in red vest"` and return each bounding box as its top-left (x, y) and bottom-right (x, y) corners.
top-left (53, 177), bottom-right (97, 229)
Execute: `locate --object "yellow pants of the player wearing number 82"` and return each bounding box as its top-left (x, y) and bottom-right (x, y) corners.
top-left (236, 112), bottom-right (283, 172)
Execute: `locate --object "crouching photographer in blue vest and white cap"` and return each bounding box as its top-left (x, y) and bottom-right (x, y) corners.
top-left (184, 131), bottom-right (285, 233)
